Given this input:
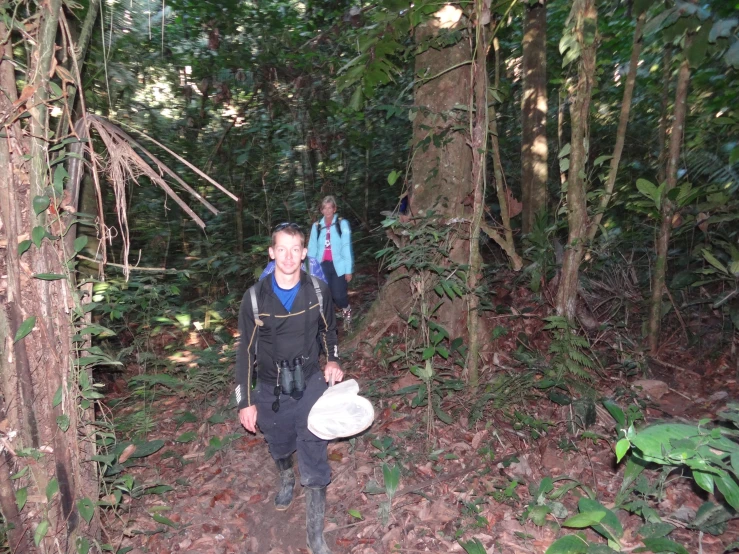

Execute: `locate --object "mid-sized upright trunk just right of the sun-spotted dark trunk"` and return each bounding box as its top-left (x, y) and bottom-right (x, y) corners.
top-left (557, 0), bottom-right (598, 322)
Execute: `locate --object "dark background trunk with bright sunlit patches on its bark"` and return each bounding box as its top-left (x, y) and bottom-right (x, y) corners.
top-left (521, 0), bottom-right (549, 234)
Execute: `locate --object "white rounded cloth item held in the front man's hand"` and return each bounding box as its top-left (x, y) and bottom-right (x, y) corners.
top-left (308, 379), bottom-right (375, 440)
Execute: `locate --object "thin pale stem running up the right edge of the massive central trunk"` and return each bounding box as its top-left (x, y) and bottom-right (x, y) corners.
top-left (466, 0), bottom-right (490, 390)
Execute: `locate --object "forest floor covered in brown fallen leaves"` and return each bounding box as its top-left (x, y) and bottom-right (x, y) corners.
top-left (106, 272), bottom-right (739, 554)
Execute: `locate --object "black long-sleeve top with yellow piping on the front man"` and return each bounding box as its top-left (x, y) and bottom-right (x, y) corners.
top-left (236, 271), bottom-right (339, 409)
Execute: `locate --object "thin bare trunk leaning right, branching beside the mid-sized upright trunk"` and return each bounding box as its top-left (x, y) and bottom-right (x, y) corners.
top-left (588, 12), bottom-right (647, 241)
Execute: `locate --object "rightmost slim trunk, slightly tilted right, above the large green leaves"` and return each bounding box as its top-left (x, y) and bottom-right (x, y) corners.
top-left (649, 60), bottom-right (690, 356)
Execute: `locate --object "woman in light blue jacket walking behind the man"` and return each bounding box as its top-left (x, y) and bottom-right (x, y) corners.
top-left (308, 196), bottom-right (354, 325)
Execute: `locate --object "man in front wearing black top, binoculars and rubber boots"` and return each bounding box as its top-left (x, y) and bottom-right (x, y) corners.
top-left (236, 223), bottom-right (344, 554)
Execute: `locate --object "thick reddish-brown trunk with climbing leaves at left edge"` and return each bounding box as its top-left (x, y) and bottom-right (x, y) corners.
top-left (0, 0), bottom-right (98, 552)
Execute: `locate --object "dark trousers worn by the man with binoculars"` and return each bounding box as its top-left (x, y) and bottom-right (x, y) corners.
top-left (254, 371), bottom-right (331, 487)
